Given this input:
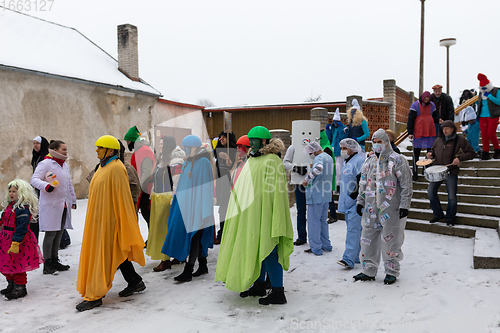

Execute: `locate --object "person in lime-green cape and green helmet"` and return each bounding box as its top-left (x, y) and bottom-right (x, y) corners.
top-left (215, 126), bottom-right (293, 305)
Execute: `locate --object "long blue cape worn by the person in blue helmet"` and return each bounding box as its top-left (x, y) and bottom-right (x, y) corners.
top-left (161, 152), bottom-right (214, 261)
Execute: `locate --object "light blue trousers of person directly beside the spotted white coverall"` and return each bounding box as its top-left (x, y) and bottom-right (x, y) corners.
top-left (342, 205), bottom-right (362, 268)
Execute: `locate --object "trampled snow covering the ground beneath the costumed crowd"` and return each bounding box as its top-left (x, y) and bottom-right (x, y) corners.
top-left (0, 200), bottom-right (500, 333)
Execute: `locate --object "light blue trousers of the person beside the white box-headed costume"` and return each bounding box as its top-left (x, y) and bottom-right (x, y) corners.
top-left (307, 202), bottom-right (332, 255)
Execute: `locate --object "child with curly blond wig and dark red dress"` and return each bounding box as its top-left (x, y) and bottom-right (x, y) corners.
top-left (0, 179), bottom-right (43, 300)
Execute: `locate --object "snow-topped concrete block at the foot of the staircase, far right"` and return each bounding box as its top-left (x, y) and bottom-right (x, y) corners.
top-left (474, 229), bottom-right (500, 269)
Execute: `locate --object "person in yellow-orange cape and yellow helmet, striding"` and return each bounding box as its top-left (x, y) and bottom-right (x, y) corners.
top-left (76, 135), bottom-right (146, 311)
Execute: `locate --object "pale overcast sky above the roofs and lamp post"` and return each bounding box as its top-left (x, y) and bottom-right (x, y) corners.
top-left (24, 0), bottom-right (500, 106)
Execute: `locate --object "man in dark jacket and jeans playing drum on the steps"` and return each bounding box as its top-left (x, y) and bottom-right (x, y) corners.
top-left (427, 120), bottom-right (475, 226)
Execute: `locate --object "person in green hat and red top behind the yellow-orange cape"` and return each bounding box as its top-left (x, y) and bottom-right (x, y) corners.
top-left (123, 126), bottom-right (155, 230)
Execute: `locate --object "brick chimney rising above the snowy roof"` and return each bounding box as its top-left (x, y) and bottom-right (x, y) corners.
top-left (118, 24), bottom-right (140, 81)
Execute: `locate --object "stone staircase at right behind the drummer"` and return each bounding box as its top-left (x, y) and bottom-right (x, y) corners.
top-left (335, 132), bottom-right (500, 269)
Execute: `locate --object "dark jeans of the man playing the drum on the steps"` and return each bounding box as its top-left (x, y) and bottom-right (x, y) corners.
top-left (427, 175), bottom-right (458, 221)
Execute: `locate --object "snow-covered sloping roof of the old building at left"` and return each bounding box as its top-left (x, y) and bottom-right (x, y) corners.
top-left (0, 7), bottom-right (161, 96)
